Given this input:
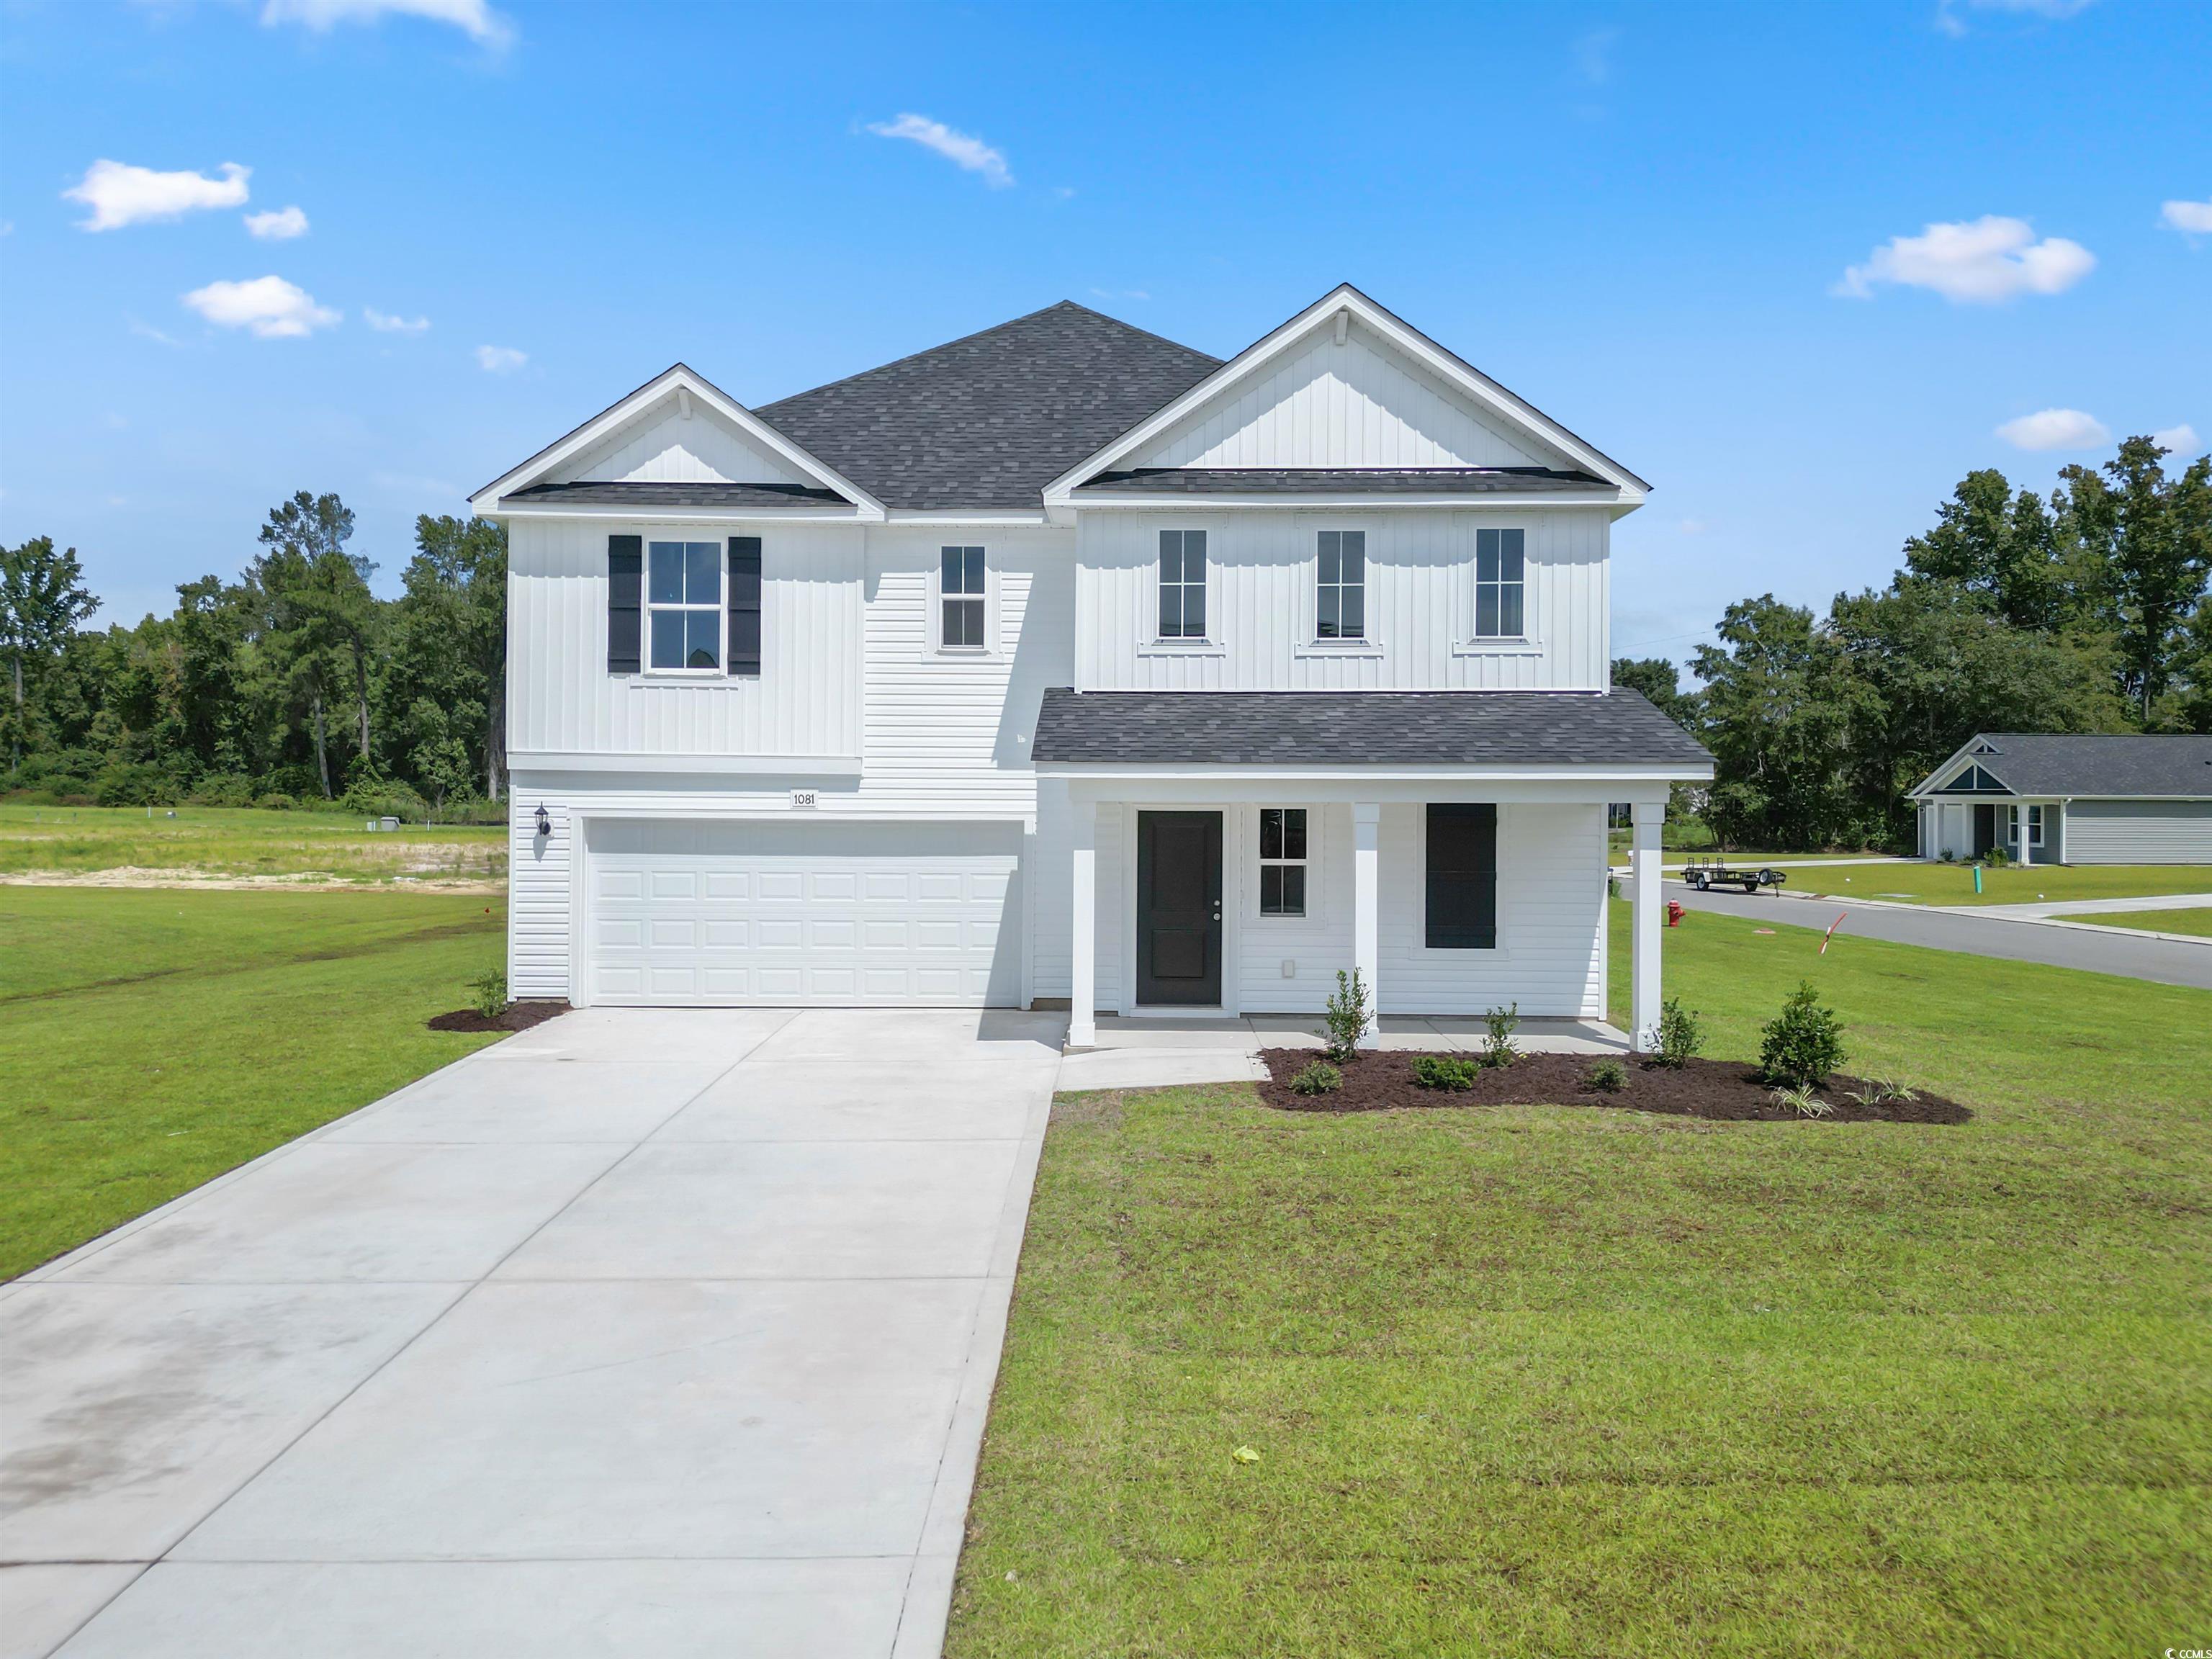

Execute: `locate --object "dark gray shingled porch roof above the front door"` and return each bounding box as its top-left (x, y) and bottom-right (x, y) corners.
top-left (1031, 688), bottom-right (1712, 776)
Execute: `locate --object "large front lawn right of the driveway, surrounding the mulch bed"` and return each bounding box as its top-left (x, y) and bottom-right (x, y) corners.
top-left (947, 904), bottom-right (2212, 1659)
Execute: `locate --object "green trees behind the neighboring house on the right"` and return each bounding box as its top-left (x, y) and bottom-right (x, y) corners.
top-left (1612, 438), bottom-right (2212, 850)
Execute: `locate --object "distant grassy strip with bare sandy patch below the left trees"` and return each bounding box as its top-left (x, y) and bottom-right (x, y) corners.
top-left (0, 801), bottom-right (506, 885)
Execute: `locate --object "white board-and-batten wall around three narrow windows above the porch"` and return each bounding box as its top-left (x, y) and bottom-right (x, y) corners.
top-left (1075, 506), bottom-right (1612, 690)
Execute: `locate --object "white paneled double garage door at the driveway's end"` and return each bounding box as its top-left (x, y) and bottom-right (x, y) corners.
top-left (586, 821), bottom-right (1022, 1007)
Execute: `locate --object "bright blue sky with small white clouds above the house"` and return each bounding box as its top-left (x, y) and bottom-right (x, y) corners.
top-left (0, 0), bottom-right (2212, 659)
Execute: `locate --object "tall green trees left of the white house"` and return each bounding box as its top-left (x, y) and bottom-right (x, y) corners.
top-left (0, 491), bottom-right (506, 821)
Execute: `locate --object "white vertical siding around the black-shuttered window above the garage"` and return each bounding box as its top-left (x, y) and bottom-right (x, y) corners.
top-left (506, 518), bottom-right (863, 770)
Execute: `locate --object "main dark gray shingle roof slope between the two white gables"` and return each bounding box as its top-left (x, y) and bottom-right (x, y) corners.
top-left (752, 301), bottom-right (1221, 509)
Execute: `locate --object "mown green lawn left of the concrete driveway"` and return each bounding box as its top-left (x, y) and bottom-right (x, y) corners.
top-left (0, 887), bottom-right (504, 1279)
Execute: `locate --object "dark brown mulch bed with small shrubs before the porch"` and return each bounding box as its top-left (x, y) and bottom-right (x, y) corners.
top-left (1259, 1048), bottom-right (1973, 1124)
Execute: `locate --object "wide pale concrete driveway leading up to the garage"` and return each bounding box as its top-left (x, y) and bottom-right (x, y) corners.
top-left (0, 1009), bottom-right (1066, 1659)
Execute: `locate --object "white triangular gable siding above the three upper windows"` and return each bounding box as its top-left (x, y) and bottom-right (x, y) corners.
top-left (1126, 325), bottom-right (1573, 467)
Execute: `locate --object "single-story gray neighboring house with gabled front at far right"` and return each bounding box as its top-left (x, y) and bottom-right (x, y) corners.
top-left (1907, 732), bottom-right (2212, 865)
